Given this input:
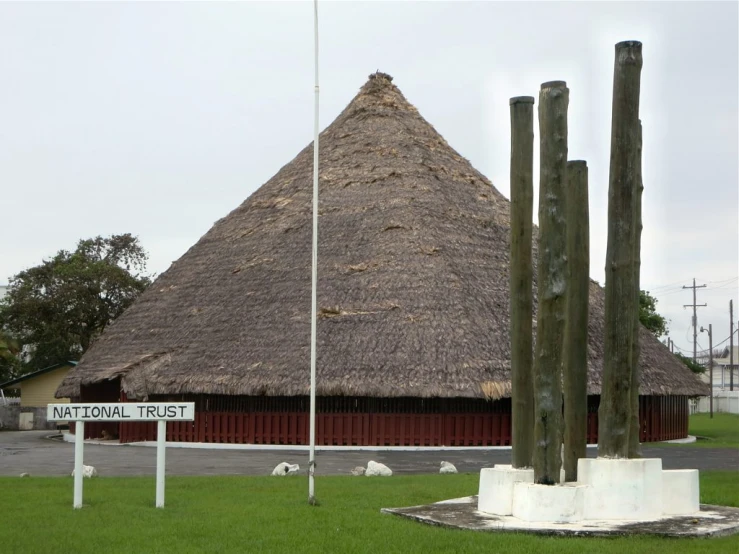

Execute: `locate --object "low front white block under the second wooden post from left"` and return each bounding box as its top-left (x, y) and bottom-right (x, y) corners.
top-left (512, 483), bottom-right (588, 523)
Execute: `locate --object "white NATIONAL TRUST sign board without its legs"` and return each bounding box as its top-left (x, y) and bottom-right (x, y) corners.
top-left (46, 402), bottom-right (195, 421)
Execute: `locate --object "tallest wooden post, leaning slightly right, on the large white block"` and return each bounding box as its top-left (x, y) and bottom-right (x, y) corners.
top-left (598, 41), bottom-right (642, 458)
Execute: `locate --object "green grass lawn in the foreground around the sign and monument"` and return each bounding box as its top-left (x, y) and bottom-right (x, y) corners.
top-left (0, 471), bottom-right (739, 554)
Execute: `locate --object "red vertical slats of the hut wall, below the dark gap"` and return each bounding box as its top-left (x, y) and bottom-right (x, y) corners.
top-left (114, 396), bottom-right (689, 446)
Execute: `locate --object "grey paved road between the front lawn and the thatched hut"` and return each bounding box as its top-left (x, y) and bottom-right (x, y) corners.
top-left (0, 431), bottom-right (739, 476)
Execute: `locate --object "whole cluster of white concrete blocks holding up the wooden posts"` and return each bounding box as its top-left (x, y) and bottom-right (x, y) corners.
top-left (477, 458), bottom-right (700, 524)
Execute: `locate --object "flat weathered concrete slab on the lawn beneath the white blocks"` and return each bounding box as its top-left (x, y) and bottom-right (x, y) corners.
top-left (381, 496), bottom-right (739, 537)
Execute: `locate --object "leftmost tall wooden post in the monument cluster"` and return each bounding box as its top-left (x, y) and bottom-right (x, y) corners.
top-left (510, 96), bottom-right (534, 468)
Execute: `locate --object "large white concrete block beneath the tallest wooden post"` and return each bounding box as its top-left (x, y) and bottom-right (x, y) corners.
top-left (577, 458), bottom-right (662, 521)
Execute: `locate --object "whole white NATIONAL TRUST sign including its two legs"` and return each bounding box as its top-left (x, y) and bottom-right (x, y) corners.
top-left (46, 402), bottom-right (195, 508)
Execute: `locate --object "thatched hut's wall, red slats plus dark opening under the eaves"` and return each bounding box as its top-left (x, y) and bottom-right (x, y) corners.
top-left (70, 391), bottom-right (688, 446)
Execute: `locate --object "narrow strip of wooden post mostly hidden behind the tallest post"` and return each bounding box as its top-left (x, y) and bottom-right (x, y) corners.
top-left (629, 121), bottom-right (644, 458)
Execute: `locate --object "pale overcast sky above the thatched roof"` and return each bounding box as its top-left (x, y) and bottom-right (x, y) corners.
top-left (0, 1), bottom-right (739, 351)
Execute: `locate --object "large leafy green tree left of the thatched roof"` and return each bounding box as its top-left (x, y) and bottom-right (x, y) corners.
top-left (0, 234), bottom-right (151, 373)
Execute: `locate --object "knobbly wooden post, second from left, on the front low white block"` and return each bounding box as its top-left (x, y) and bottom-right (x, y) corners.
top-left (534, 81), bottom-right (569, 485)
